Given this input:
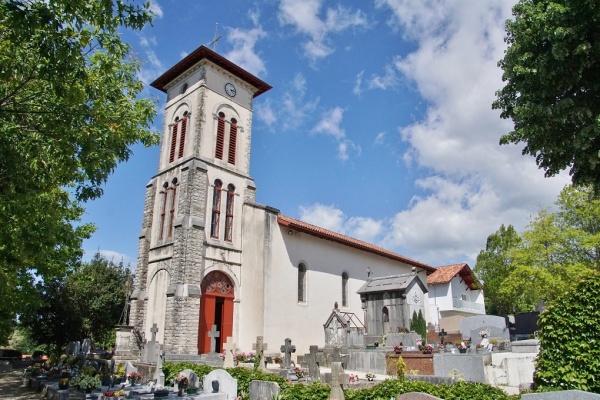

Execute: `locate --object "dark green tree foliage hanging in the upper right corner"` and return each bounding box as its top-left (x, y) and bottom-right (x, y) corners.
top-left (493, 0), bottom-right (600, 187)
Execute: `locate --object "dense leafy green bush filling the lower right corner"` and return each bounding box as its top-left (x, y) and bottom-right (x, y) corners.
top-left (534, 272), bottom-right (600, 393)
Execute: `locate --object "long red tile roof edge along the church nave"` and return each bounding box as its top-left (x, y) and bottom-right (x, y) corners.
top-left (277, 214), bottom-right (435, 274)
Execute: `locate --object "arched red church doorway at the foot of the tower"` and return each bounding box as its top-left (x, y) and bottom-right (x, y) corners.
top-left (198, 271), bottom-right (235, 354)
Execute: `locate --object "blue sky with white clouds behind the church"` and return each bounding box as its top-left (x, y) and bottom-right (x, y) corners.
top-left (84, 0), bottom-right (569, 267)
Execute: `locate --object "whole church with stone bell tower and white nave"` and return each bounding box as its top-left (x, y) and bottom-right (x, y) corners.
top-left (130, 46), bottom-right (435, 359)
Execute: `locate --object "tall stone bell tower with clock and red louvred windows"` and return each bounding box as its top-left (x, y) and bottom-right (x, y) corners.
top-left (130, 46), bottom-right (271, 355)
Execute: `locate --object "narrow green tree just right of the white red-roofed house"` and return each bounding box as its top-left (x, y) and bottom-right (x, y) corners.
top-left (473, 225), bottom-right (521, 314)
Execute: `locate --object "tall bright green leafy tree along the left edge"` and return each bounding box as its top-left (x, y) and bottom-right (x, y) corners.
top-left (0, 0), bottom-right (158, 343)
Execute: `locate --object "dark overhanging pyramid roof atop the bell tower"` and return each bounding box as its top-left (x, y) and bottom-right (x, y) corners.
top-left (150, 46), bottom-right (271, 97)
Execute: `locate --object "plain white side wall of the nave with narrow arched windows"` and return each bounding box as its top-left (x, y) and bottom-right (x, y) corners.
top-left (264, 223), bottom-right (428, 353)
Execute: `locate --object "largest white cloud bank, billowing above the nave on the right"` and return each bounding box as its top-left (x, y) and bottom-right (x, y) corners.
top-left (301, 0), bottom-right (568, 266)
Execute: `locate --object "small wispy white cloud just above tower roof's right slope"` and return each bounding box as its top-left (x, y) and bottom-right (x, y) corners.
top-left (224, 11), bottom-right (267, 75)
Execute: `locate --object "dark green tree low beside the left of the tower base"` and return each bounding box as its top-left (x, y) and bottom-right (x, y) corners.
top-left (21, 253), bottom-right (132, 353)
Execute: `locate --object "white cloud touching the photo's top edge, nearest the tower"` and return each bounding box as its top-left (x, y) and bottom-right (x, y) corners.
top-left (279, 0), bottom-right (367, 61)
